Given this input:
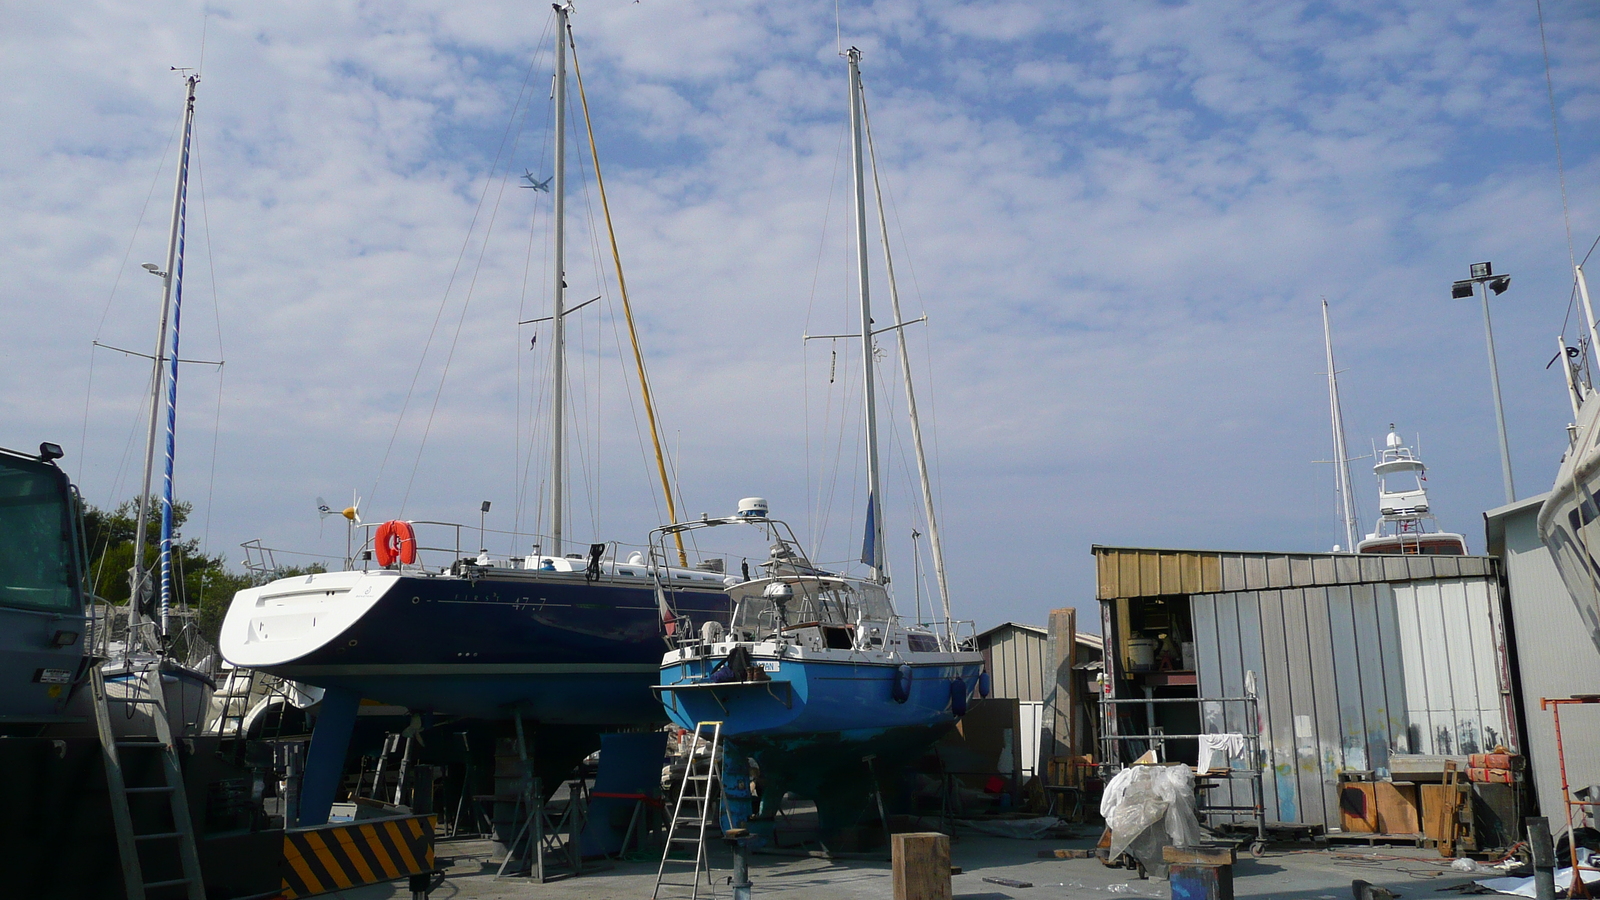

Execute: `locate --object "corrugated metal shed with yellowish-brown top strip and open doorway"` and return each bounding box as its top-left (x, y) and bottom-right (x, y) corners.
top-left (1093, 546), bottom-right (1517, 826)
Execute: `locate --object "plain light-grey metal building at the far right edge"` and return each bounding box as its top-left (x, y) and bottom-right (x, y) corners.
top-left (1483, 495), bottom-right (1600, 831)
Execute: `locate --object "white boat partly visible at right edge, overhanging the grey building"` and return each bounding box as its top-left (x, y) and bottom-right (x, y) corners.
top-left (1539, 264), bottom-right (1600, 650)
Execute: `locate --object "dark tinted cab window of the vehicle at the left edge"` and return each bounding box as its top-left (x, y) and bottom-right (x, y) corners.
top-left (0, 456), bottom-right (78, 610)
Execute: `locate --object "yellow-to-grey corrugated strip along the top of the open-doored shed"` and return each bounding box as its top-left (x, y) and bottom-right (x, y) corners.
top-left (1091, 544), bottom-right (1496, 601)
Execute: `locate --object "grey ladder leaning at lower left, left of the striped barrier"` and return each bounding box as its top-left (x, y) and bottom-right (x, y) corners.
top-left (90, 665), bottom-right (205, 900)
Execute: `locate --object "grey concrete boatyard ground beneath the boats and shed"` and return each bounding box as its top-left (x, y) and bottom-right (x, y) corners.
top-left (325, 833), bottom-right (1483, 900)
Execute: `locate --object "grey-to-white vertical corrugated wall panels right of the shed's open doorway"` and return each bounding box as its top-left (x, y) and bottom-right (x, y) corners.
top-left (1190, 573), bottom-right (1509, 826)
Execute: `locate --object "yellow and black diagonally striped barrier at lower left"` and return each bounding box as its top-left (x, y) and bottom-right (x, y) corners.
top-left (283, 815), bottom-right (435, 900)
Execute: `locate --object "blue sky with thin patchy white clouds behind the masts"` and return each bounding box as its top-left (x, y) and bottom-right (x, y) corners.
top-left (0, 0), bottom-right (1600, 628)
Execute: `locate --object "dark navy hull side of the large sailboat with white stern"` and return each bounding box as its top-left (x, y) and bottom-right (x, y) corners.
top-left (262, 577), bottom-right (728, 725)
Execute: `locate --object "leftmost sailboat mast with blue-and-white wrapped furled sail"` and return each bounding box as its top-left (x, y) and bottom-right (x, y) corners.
top-left (128, 75), bottom-right (200, 634)
